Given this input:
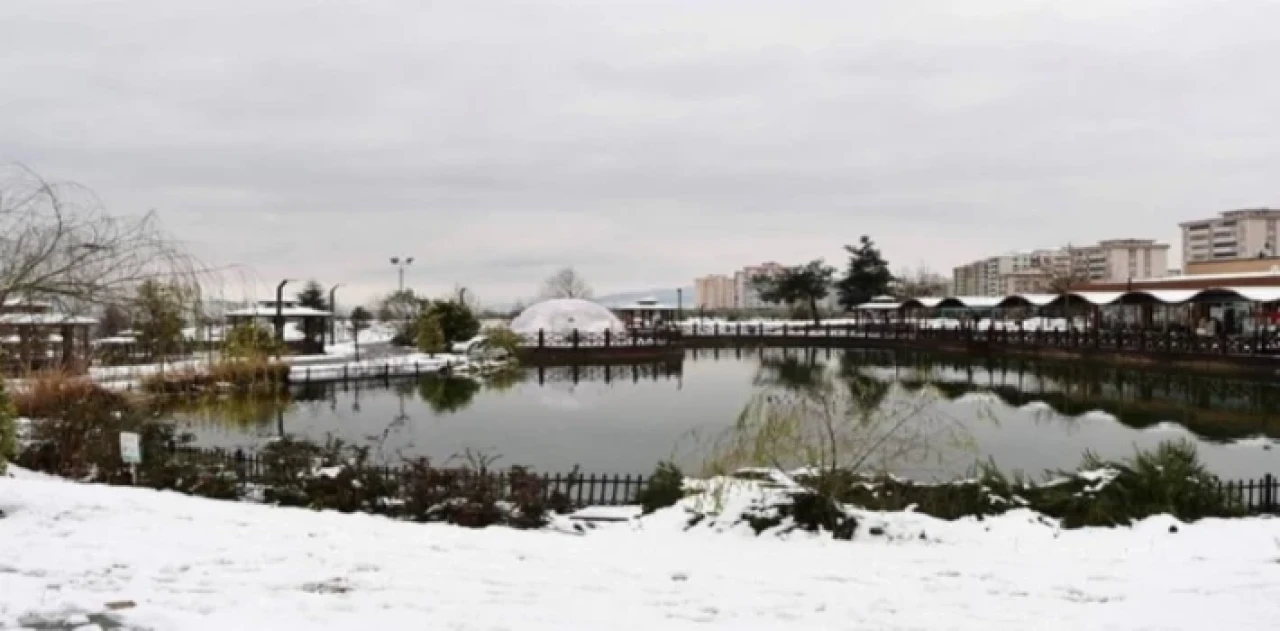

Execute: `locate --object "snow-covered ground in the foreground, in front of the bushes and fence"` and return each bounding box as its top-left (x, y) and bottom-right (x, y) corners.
top-left (0, 472), bottom-right (1280, 631)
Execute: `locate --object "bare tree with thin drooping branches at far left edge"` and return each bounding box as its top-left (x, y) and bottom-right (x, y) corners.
top-left (0, 165), bottom-right (198, 312)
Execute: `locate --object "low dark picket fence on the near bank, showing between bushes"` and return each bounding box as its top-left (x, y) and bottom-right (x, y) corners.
top-left (177, 449), bottom-right (1280, 515)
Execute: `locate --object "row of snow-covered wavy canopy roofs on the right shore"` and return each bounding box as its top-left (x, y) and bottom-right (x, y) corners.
top-left (858, 287), bottom-right (1280, 311)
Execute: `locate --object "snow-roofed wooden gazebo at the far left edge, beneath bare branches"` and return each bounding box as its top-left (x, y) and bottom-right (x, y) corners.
top-left (0, 301), bottom-right (97, 372)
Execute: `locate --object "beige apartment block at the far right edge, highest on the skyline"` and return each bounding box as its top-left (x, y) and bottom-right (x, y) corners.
top-left (1179, 209), bottom-right (1280, 268)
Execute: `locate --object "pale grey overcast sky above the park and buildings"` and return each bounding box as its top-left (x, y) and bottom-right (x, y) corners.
top-left (0, 0), bottom-right (1280, 302)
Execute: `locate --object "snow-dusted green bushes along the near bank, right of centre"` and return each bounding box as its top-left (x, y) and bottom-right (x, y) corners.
top-left (686, 442), bottom-right (1245, 538)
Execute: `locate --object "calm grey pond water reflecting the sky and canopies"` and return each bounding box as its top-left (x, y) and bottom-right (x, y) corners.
top-left (179, 349), bottom-right (1280, 479)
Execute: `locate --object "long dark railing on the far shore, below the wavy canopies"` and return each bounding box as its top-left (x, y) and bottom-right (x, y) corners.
top-left (685, 323), bottom-right (1280, 356)
